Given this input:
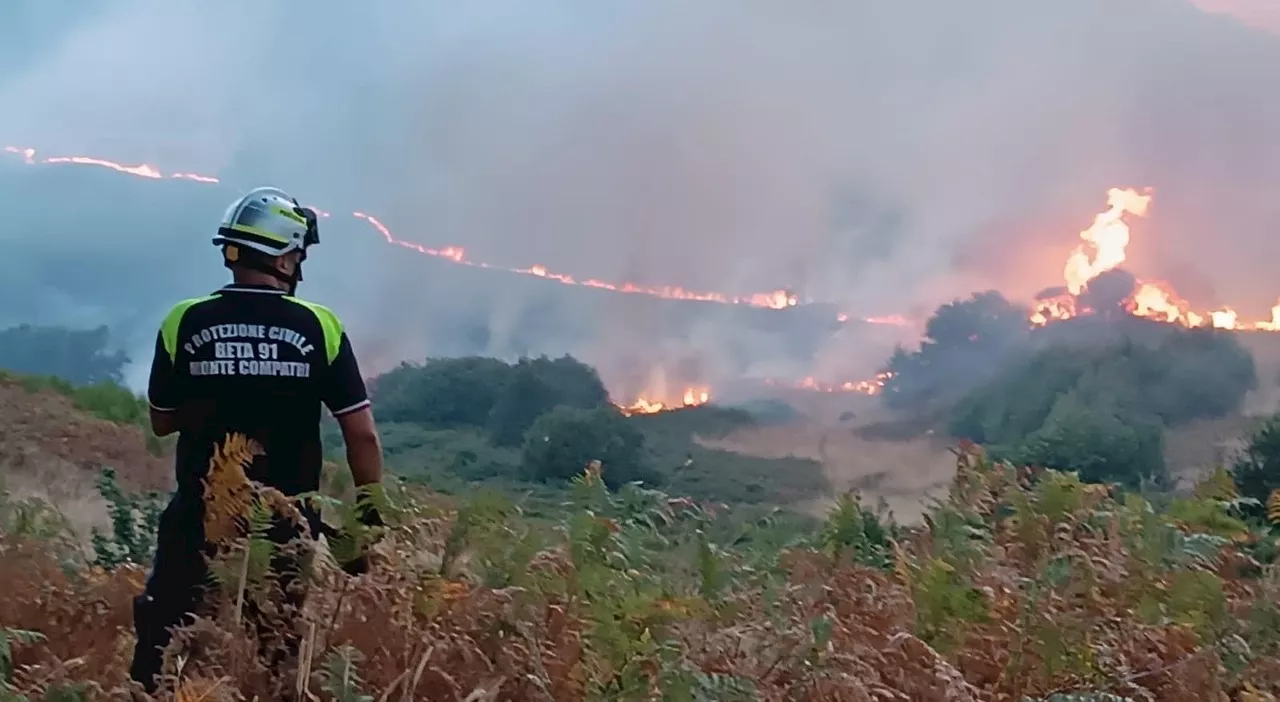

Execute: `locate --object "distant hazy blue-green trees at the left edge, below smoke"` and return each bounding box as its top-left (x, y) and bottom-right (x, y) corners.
top-left (0, 324), bottom-right (129, 386)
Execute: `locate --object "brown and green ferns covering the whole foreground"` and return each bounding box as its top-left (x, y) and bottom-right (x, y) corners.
top-left (0, 447), bottom-right (1280, 702)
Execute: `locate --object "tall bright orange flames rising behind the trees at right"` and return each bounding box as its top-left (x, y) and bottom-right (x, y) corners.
top-left (1030, 188), bottom-right (1280, 332)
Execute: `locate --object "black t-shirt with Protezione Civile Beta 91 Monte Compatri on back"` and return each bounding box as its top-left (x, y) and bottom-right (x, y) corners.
top-left (147, 284), bottom-right (369, 498)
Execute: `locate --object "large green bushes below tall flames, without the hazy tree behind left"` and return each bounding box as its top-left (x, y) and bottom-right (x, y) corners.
top-left (948, 329), bottom-right (1257, 487)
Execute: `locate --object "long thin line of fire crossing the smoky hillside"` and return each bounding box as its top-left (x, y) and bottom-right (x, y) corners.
top-left (4, 146), bottom-right (906, 325)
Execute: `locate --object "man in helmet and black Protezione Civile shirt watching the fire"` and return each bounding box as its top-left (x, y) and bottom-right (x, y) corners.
top-left (129, 187), bottom-right (383, 692)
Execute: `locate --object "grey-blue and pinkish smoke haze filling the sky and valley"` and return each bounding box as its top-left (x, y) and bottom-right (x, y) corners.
top-left (0, 0), bottom-right (1280, 394)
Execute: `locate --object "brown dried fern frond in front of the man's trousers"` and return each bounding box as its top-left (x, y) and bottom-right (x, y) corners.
top-left (202, 433), bottom-right (265, 544)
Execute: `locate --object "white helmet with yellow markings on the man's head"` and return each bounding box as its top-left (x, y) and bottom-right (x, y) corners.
top-left (214, 187), bottom-right (320, 256)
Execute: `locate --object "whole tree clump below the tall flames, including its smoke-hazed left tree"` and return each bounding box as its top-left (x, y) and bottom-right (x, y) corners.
top-left (884, 288), bottom-right (1257, 487)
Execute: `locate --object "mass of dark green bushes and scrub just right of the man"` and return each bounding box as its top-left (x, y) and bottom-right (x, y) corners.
top-left (324, 356), bottom-right (827, 514)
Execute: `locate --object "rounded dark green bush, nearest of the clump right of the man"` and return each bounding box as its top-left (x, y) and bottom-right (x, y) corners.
top-left (522, 406), bottom-right (658, 488)
